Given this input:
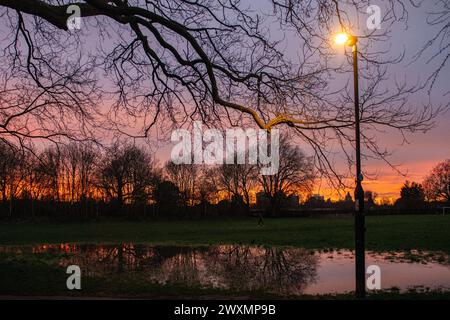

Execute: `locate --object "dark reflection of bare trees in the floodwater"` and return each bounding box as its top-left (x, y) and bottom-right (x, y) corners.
top-left (26, 244), bottom-right (318, 294)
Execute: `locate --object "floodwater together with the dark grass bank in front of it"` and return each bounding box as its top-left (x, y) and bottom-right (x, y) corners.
top-left (0, 243), bottom-right (450, 299)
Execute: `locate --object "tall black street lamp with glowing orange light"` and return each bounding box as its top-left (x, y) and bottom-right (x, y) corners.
top-left (335, 33), bottom-right (366, 298)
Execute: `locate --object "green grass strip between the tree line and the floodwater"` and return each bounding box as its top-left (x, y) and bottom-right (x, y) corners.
top-left (0, 215), bottom-right (450, 253)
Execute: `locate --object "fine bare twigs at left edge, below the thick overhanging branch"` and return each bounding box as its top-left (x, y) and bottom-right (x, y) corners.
top-left (0, 1), bottom-right (100, 148)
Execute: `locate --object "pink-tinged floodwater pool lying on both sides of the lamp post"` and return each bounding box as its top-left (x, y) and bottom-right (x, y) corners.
top-left (0, 244), bottom-right (450, 295)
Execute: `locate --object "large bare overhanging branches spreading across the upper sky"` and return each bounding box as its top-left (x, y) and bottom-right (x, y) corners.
top-left (0, 0), bottom-right (447, 186)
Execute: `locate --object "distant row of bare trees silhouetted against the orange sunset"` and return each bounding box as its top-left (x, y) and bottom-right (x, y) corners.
top-left (0, 138), bottom-right (314, 220)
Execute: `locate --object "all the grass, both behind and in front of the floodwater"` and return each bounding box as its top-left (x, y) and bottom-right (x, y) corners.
top-left (0, 215), bottom-right (450, 299)
